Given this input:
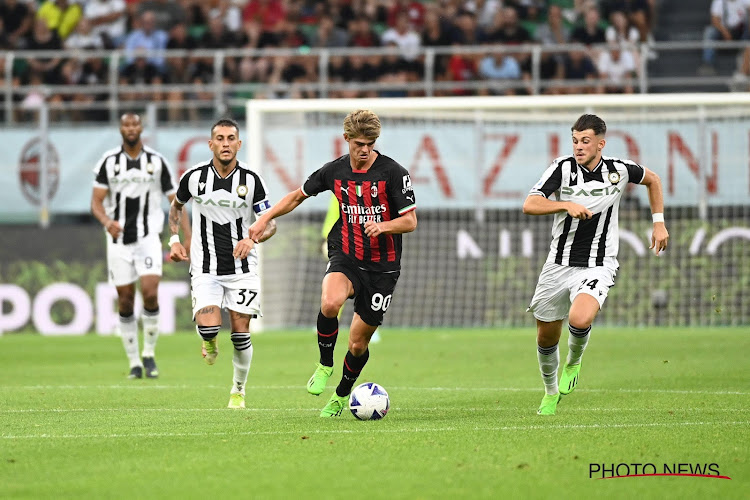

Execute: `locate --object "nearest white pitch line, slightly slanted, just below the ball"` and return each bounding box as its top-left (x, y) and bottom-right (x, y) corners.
top-left (0, 421), bottom-right (750, 440)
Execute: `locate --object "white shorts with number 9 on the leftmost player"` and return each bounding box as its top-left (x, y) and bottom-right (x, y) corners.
top-left (107, 234), bottom-right (164, 286)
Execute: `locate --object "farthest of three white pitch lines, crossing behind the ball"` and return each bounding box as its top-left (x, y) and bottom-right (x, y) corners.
top-left (5, 382), bottom-right (750, 396)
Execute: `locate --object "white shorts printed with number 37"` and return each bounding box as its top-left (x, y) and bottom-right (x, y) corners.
top-left (190, 273), bottom-right (262, 319)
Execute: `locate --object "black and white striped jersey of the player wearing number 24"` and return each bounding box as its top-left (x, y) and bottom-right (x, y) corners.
top-left (529, 156), bottom-right (646, 267)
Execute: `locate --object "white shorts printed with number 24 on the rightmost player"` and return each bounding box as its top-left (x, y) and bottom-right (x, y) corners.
top-left (527, 262), bottom-right (617, 322)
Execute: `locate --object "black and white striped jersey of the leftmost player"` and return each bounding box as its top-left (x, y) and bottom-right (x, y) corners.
top-left (94, 146), bottom-right (175, 245)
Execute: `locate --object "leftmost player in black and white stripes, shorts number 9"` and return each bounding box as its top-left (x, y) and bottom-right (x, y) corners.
top-left (91, 113), bottom-right (190, 378)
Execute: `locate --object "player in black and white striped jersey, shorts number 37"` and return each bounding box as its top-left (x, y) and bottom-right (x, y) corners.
top-left (169, 119), bottom-right (276, 408)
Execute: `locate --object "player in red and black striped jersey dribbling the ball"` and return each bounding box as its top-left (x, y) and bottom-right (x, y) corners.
top-left (250, 110), bottom-right (417, 417)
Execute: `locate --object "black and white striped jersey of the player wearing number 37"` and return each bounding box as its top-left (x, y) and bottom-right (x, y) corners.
top-left (176, 160), bottom-right (271, 276)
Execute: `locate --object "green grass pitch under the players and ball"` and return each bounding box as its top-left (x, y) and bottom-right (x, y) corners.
top-left (0, 327), bottom-right (750, 499)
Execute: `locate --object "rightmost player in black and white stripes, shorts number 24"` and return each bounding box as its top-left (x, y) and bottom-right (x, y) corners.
top-left (523, 114), bottom-right (669, 415)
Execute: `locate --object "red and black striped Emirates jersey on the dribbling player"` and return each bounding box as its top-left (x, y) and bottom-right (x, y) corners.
top-left (301, 151), bottom-right (417, 272)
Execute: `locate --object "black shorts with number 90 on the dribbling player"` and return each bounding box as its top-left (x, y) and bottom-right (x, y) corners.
top-left (326, 254), bottom-right (401, 326)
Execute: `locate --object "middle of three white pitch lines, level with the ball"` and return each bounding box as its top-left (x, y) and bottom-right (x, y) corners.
top-left (0, 406), bottom-right (750, 414)
